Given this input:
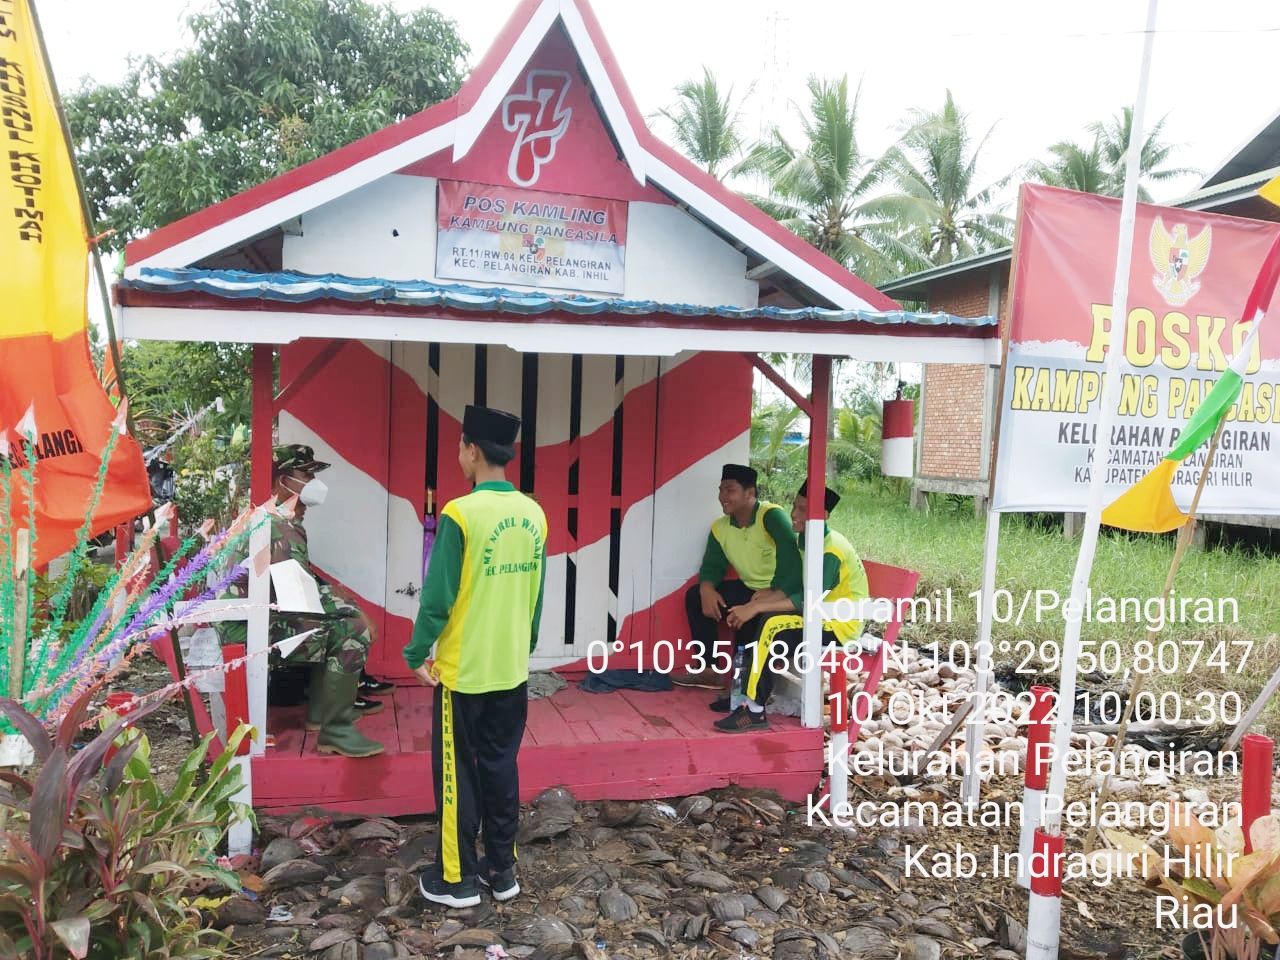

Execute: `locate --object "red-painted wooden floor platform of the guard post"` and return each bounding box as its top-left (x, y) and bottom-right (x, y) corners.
top-left (253, 681), bottom-right (823, 815)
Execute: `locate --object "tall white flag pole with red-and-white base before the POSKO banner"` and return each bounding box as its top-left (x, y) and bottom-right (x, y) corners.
top-left (1027, 7), bottom-right (1158, 960)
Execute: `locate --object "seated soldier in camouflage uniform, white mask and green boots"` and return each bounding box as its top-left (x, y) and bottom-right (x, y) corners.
top-left (219, 443), bottom-right (384, 756)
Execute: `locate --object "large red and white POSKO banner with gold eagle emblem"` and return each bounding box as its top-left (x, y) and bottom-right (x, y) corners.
top-left (992, 184), bottom-right (1280, 515)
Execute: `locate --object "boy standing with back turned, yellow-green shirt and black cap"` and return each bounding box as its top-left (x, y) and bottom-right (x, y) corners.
top-left (404, 406), bottom-right (547, 906)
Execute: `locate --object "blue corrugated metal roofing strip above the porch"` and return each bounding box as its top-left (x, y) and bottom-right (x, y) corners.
top-left (120, 268), bottom-right (996, 329)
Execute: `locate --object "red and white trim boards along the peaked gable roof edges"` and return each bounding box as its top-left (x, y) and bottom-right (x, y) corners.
top-left (125, 0), bottom-right (897, 310)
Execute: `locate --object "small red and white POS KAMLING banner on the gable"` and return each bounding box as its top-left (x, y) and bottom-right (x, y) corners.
top-left (435, 180), bottom-right (627, 293)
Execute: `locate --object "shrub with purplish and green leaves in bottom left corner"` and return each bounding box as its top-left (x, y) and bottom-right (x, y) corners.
top-left (0, 689), bottom-right (252, 960)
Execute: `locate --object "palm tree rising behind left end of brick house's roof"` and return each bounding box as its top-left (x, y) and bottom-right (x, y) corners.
top-left (870, 90), bottom-right (1012, 265)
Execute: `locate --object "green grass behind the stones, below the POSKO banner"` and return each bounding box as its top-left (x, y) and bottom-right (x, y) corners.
top-left (832, 481), bottom-right (1280, 718)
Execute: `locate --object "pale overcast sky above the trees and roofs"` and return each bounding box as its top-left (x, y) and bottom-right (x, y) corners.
top-left (36, 0), bottom-right (1280, 201)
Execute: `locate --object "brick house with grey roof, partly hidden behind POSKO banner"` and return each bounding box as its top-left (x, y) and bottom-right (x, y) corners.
top-left (881, 113), bottom-right (1280, 512)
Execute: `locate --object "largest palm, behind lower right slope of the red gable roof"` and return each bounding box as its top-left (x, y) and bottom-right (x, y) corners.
top-left (733, 77), bottom-right (909, 283)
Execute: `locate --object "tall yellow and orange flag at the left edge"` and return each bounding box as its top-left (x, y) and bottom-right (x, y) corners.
top-left (0, 0), bottom-right (151, 567)
